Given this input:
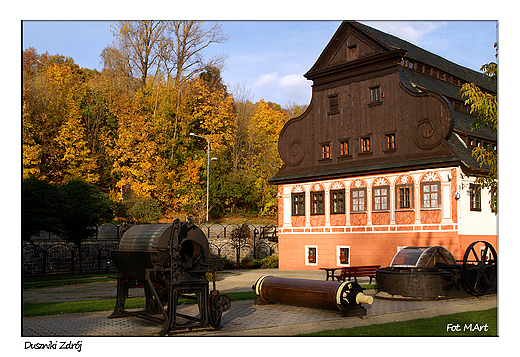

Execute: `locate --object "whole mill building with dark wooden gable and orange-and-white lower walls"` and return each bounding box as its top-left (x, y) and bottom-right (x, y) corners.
top-left (270, 22), bottom-right (497, 269)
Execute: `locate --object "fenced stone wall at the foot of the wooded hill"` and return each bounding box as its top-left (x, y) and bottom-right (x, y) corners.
top-left (22, 223), bottom-right (278, 276)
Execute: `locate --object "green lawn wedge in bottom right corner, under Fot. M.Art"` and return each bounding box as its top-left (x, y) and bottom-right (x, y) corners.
top-left (299, 308), bottom-right (498, 337)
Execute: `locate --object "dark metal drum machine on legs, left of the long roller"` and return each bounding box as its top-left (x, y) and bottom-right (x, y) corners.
top-left (109, 219), bottom-right (231, 335)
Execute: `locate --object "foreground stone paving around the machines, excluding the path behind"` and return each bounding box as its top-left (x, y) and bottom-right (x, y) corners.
top-left (23, 295), bottom-right (496, 337)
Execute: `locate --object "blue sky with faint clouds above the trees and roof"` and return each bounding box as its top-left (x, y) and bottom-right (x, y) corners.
top-left (22, 20), bottom-right (497, 107)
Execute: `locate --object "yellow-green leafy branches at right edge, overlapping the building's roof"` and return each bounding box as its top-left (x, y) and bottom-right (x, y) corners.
top-left (461, 43), bottom-right (498, 214)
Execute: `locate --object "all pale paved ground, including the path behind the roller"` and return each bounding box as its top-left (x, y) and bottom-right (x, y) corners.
top-left (22, 270), bottom-right (497, 337)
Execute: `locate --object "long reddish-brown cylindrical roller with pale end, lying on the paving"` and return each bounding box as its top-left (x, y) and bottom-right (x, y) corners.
top-left (253, 276), bottom-right (373, 316)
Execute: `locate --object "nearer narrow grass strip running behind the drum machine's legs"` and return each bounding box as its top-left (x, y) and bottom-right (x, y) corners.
top-left (22, 291), bottom-right (256, 317)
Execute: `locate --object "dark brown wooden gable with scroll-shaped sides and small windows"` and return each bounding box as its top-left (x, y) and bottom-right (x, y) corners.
top-left (270, 22), bottom-right (458, 183)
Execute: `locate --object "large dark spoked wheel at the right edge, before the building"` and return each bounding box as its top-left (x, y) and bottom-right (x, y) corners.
top-left (462, 241), bottom-right (498, 296)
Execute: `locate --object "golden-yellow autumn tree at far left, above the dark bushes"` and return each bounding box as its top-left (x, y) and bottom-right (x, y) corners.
top-left (22, 49), bottom-right (99, 183)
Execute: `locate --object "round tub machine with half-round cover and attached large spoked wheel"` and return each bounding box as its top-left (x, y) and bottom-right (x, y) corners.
top-left (376, 241), bottom-right (498, 300)
